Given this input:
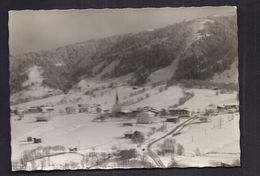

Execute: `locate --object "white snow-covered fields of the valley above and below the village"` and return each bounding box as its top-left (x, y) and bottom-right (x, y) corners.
top-left (11, 81), bottom-right (240, 169)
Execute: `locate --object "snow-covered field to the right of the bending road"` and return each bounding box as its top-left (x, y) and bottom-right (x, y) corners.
top-left (154, 113), bottom-right (240, 167)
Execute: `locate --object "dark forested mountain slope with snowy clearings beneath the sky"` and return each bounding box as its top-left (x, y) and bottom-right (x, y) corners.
top-left (10, 16), bottom-right (237, 99)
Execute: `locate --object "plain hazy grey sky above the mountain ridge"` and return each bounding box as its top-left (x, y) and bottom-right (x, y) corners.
top-left (9, 6), bottom-right (236, 55)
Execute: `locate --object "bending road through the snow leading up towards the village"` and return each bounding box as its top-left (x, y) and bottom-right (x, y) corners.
top-left (147, 117), bottom-right (197, 168)
